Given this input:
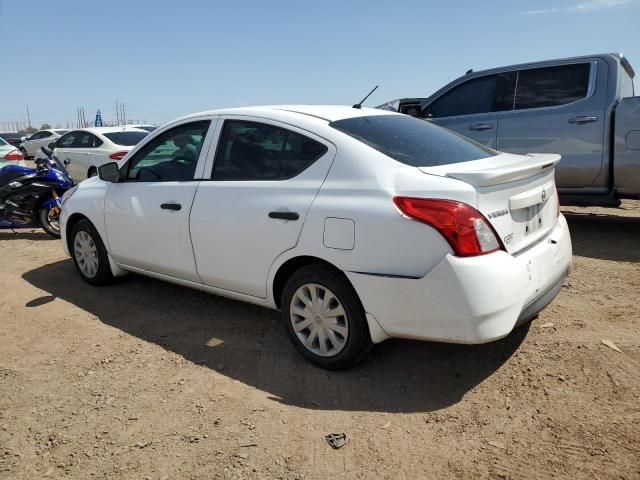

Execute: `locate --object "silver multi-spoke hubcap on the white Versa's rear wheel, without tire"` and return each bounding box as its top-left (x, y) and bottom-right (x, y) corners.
top-left (289, 283), bottom-right (349, 357)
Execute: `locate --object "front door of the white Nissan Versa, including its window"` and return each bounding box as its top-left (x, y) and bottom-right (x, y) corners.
top-left (104, 119), bottom-right (212, 282)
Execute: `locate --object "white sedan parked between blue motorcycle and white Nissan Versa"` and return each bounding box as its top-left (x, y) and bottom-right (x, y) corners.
top-left (54, 127), bottom-right (149, 182)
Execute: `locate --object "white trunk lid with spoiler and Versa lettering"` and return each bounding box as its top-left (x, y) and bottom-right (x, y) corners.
top-left (420, 153), bottom-right (560, 253)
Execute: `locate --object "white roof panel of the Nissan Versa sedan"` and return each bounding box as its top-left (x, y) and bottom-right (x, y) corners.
top-left (179, 105), bottom-right (394, 122)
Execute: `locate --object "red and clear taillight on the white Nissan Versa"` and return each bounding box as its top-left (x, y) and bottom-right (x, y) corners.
top-left (393, 197), bottom-right (502, 257)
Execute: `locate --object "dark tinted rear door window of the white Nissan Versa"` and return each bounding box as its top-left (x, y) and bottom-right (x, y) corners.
top-left (212, 120), bottom-right (328, 180)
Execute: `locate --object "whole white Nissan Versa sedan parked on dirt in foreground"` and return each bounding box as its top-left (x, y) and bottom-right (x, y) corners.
top-left (60, 106), bottom-right (571, 369)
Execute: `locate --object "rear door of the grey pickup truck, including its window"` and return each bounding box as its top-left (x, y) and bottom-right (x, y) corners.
top-left (498, 60), bottom-right (608, 188)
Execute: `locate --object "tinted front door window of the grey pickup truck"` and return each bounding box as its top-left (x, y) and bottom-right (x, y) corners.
top-left (425, 72), bottom-right (515, 118)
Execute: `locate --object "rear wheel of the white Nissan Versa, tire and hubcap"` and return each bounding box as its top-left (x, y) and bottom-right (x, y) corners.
top-left (280, 265), bottom-right (372, 370)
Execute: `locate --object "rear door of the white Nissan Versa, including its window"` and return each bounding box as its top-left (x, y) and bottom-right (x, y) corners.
top-left (190, 117), bottom-right (335, 298)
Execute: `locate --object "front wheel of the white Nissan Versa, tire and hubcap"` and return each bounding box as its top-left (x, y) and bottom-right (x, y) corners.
top-left (69, 219), bottom-right (113, 285)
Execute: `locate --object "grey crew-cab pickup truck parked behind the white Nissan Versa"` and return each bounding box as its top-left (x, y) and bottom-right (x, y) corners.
top-left (381, 54), bottom-right (640, 206)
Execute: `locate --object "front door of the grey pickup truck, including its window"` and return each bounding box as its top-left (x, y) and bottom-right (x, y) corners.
top-left (423, 72), bottom-right (515, 148)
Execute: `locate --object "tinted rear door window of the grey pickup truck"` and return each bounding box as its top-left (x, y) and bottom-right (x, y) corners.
top-left (515, 63), bottom-right (591, 110)
